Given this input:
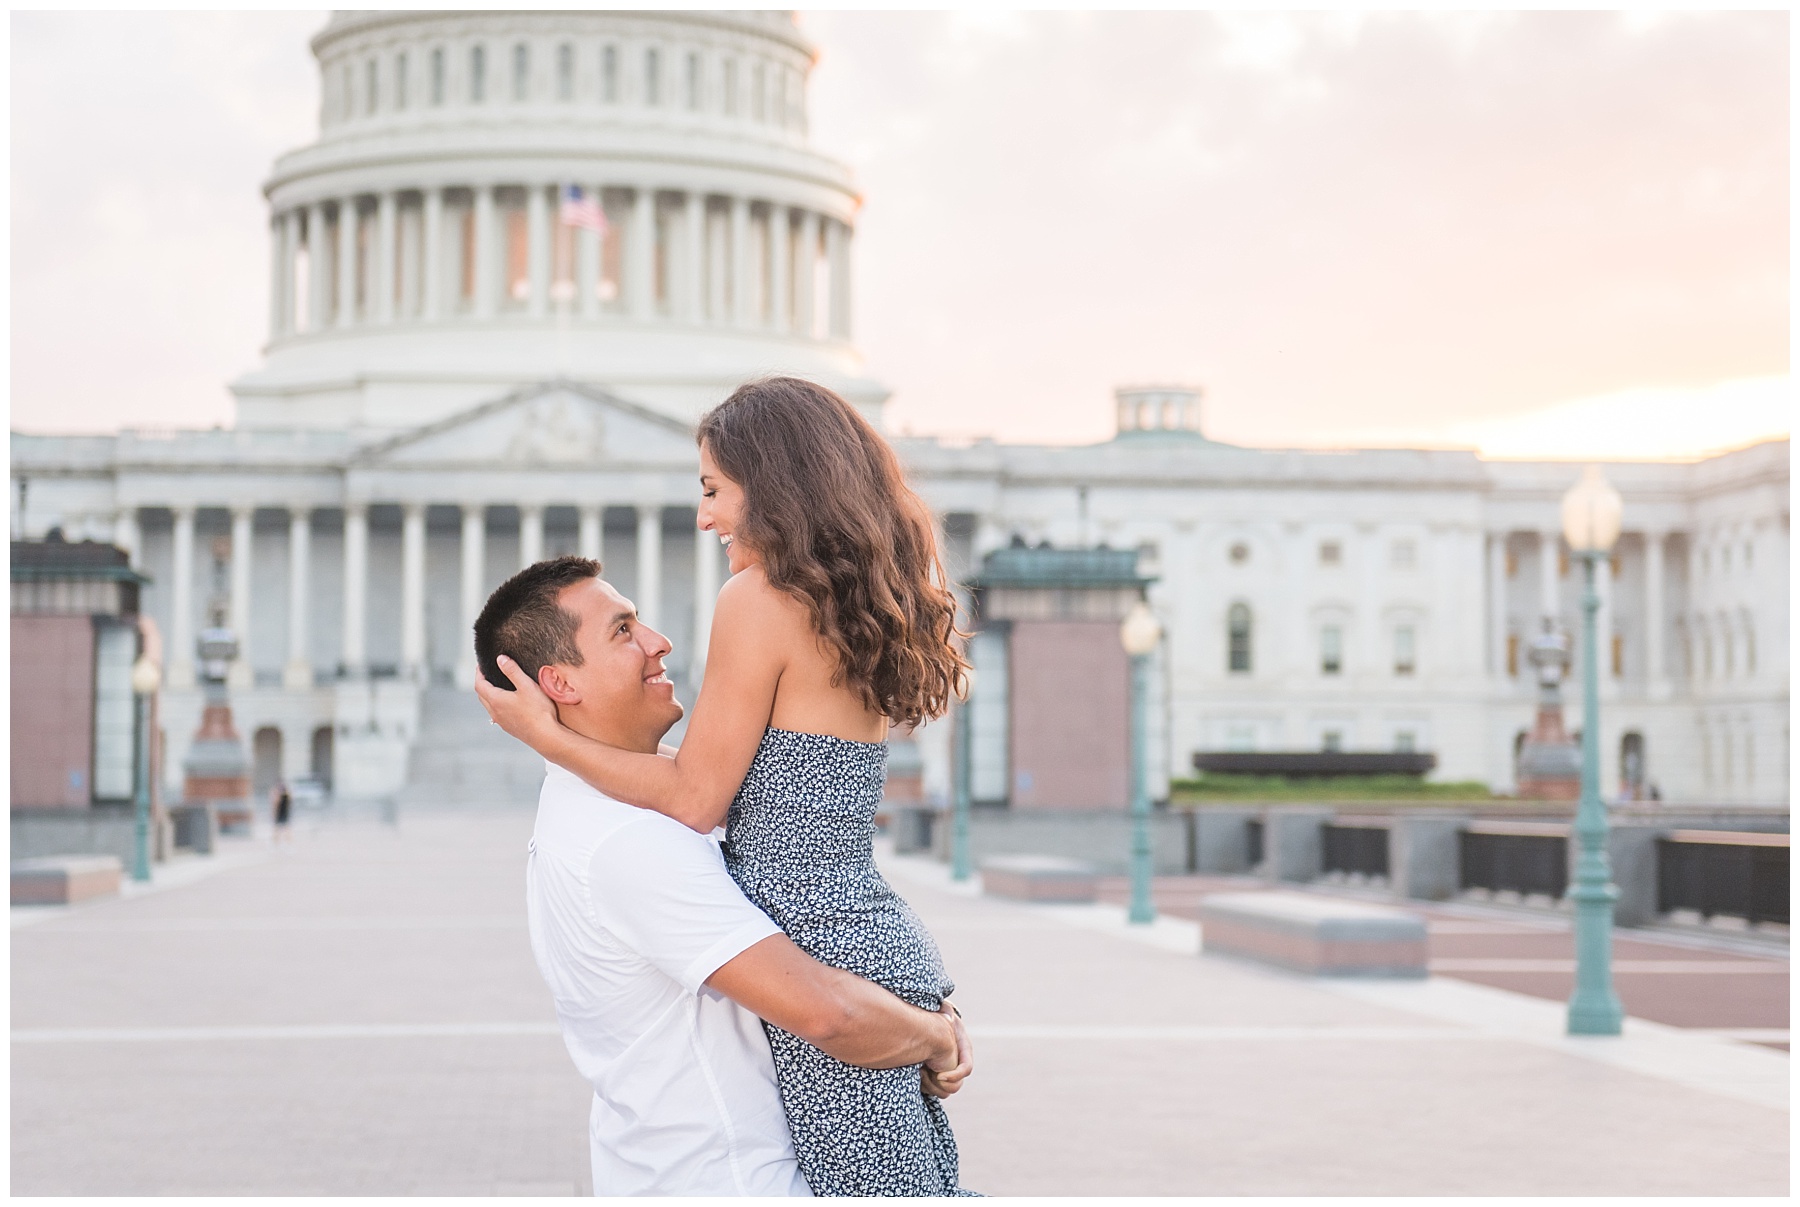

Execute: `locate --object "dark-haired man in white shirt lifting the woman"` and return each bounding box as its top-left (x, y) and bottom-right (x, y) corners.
top-left (475, 558), bottom-right (968, 1194)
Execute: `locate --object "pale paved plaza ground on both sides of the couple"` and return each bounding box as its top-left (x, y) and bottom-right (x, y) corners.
top-left (11, 811), bottom-right (1787, 1194)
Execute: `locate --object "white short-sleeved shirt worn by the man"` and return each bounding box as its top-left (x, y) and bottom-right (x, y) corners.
top-left (526, 764), bottom-right (808, 1194)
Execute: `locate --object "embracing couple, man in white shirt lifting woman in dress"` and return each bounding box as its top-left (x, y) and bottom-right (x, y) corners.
top-left (475, 378), bottom-right (972, 1196)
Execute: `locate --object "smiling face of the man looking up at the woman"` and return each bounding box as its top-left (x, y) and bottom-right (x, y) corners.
top-left (545, 577), bottom-right (682, 743)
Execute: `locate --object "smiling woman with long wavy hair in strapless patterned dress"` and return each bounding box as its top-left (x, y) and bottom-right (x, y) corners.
top-left (477, 378), bottom-right (967, 1194)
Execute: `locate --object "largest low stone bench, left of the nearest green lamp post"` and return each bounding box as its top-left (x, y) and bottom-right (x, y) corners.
top-left (1201, 892), bottom-right (1426, 977)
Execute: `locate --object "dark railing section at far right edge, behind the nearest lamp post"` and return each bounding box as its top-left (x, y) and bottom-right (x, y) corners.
top-left (1656, 829), bottom-right (1787, 925)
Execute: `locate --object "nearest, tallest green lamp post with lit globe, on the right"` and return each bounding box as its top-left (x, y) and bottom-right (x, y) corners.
top-left (1562, 466), bottom-right (1625, 1034)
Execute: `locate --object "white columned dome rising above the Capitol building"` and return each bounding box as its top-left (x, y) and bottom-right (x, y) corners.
top-left (232, 13), bottom-right (887, 437)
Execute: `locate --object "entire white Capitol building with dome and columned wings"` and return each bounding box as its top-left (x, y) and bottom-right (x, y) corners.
top-left (11, 11), bottom-right (1789, 804)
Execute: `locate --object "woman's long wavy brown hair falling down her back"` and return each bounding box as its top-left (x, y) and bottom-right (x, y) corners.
top-left (698, 378), bottom-right (968, 725)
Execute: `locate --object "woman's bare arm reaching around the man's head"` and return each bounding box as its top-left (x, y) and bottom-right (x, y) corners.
top-left (475, 572), bottom-right (785, 835)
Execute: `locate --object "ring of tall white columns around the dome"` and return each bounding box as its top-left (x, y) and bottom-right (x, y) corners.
top-left (270, 182), bottom-right (851, 344)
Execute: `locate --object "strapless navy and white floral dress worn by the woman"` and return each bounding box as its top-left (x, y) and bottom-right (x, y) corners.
top-left (724, 729), bottom-right (967, 1194)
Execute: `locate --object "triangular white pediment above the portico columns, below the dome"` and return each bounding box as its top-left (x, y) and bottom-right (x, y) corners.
top-left (356, 381), bottom-right (697, 469)
